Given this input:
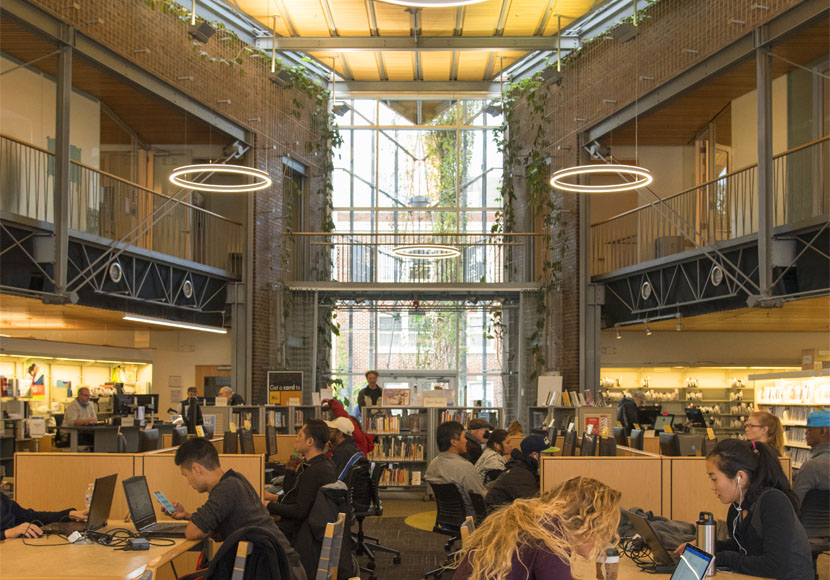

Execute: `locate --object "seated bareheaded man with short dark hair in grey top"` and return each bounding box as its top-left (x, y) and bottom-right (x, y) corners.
top-left (424, 421), bottom-right (487, 516)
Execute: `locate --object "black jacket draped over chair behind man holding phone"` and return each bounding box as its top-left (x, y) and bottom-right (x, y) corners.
top-left (180, 526), bottom-right (306, 580)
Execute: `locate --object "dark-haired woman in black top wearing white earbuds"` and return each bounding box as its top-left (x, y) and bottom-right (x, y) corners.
top-left (706, 439), bottom-right (815, 580)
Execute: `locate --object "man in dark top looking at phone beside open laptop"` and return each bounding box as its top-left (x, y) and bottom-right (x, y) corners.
top-left (162, 437), bottom-right (306, 580)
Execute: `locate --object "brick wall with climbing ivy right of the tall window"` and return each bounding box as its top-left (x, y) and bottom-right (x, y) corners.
top-left (511, 0), bottom-right (798, 389)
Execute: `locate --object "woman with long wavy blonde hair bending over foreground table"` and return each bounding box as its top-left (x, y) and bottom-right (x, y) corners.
top-left (453, 477), bottom-right (620, 580)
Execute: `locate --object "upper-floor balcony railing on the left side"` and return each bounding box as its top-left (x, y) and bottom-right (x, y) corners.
top-left (0, 135), bottom-right (245, 274)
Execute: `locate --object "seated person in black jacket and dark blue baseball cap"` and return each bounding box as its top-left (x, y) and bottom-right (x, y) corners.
top-left (484, 435), bottom-right (550, 512)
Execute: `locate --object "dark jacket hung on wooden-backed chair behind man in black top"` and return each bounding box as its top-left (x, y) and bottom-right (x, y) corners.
top-left (294, 481), bottom-right (355, 580)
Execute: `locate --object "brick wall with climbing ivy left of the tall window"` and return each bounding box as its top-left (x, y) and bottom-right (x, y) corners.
top-left (32, 0), bottom-right (325, 402)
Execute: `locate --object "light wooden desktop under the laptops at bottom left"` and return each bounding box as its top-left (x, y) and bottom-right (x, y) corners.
top-left (0, 536), bottom-right (200, 580)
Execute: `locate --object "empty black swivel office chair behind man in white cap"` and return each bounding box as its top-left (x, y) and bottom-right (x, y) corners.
top-left (346, 458), bottom-right (401, 578)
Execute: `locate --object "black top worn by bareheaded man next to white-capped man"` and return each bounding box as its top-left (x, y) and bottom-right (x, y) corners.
top-left (268, 453), bottom-right (337, 545)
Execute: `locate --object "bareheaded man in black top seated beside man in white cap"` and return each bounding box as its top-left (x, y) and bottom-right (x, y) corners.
top-left (265, 419), bottom-right (337, 543)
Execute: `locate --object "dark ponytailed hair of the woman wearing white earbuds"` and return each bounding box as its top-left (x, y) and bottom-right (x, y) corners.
top-left (706, 439), bottom-right (799, 514)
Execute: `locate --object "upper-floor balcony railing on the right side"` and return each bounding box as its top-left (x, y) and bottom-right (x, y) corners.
top-left (591, 137), bottom-right (830, 275)
